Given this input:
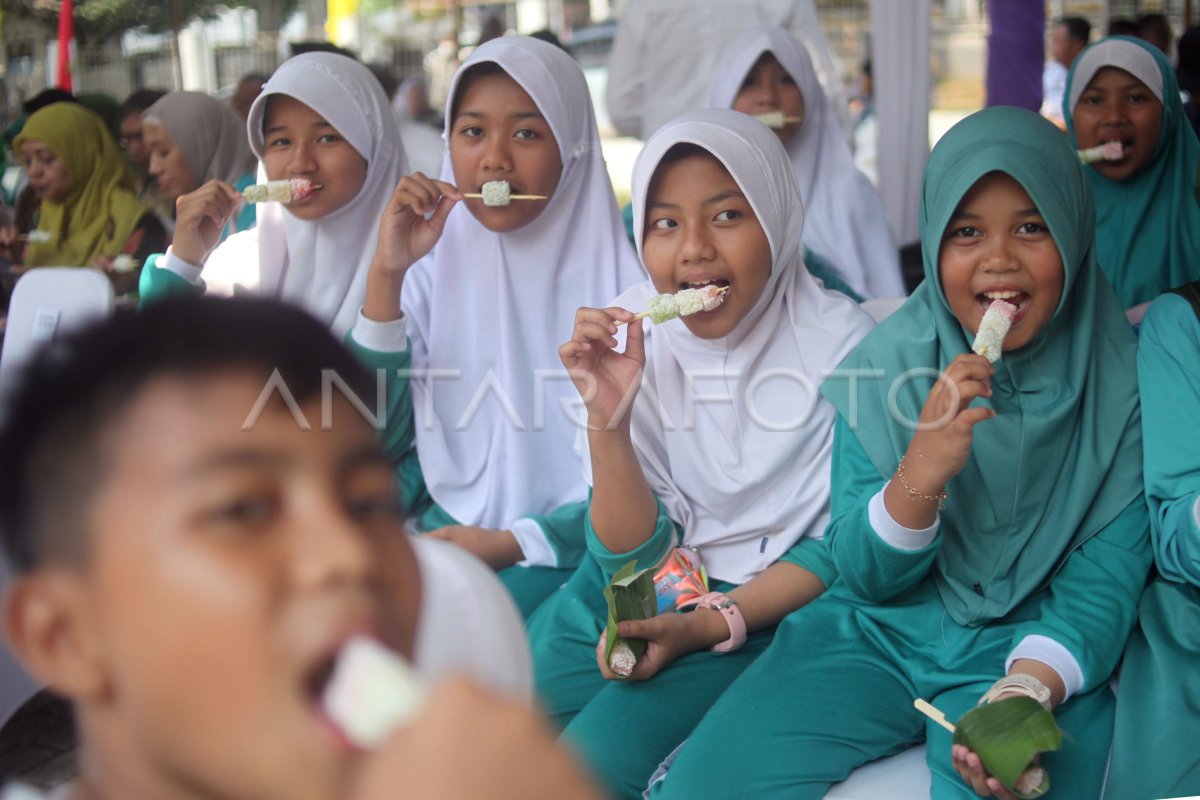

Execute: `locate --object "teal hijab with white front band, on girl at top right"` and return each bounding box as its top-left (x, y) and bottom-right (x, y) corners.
top-left (1063, 36), bottom-right (1200, 308)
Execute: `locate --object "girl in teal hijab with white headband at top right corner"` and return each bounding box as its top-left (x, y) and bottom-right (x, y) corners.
top-left (1063, 36), bottom-right (1200, 308)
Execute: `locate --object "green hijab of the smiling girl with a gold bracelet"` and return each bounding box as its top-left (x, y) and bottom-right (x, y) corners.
top-left (821, 107), bottom-right (1141, 625)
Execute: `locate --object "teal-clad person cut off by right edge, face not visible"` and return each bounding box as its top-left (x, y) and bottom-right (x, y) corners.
top-left (1106, 283), bottom-right (1200, 800)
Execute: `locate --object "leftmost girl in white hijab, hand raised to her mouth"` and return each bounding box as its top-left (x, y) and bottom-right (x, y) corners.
top-left (142, 53), bottom-right (408, 343)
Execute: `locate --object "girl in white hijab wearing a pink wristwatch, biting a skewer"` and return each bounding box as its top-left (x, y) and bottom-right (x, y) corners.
top-left (530, 109), bottom-right (871, 796)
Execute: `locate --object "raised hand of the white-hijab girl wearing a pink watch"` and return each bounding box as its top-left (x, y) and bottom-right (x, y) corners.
top-left (558, 308), bottom-right (646, 431)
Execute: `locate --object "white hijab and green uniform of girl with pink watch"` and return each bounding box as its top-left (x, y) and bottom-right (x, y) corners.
top-left (529, 109), bottom-right (871, 798)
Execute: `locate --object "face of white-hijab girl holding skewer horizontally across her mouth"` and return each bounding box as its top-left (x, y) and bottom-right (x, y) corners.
top-left (449, 74), bottom-right (563, 233)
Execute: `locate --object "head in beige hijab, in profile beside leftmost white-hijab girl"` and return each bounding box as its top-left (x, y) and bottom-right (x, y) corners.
top-left (142, 91), bottom-right (257, 230)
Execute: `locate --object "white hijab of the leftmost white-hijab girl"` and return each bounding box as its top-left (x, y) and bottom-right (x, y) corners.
top-left (204, 53), bottom-right (408, 336)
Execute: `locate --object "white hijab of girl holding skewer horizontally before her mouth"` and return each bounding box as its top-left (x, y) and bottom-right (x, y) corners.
top-left (401, 36), bottom-right (643, 528)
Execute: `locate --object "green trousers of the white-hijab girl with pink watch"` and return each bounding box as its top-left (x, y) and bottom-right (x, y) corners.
top-left (529, 555), bottom-right (774, 798)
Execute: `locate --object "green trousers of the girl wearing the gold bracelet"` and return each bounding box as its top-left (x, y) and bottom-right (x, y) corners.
top-left (653, 581), bottom-right (1115, 800)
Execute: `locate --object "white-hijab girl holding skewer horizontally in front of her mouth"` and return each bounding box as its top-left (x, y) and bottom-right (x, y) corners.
top-left (352, 36), bottom-right (641, 614)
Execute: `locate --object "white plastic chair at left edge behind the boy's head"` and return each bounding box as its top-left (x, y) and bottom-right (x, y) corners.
top-left (0, 266), bottom-right (115, 723)
